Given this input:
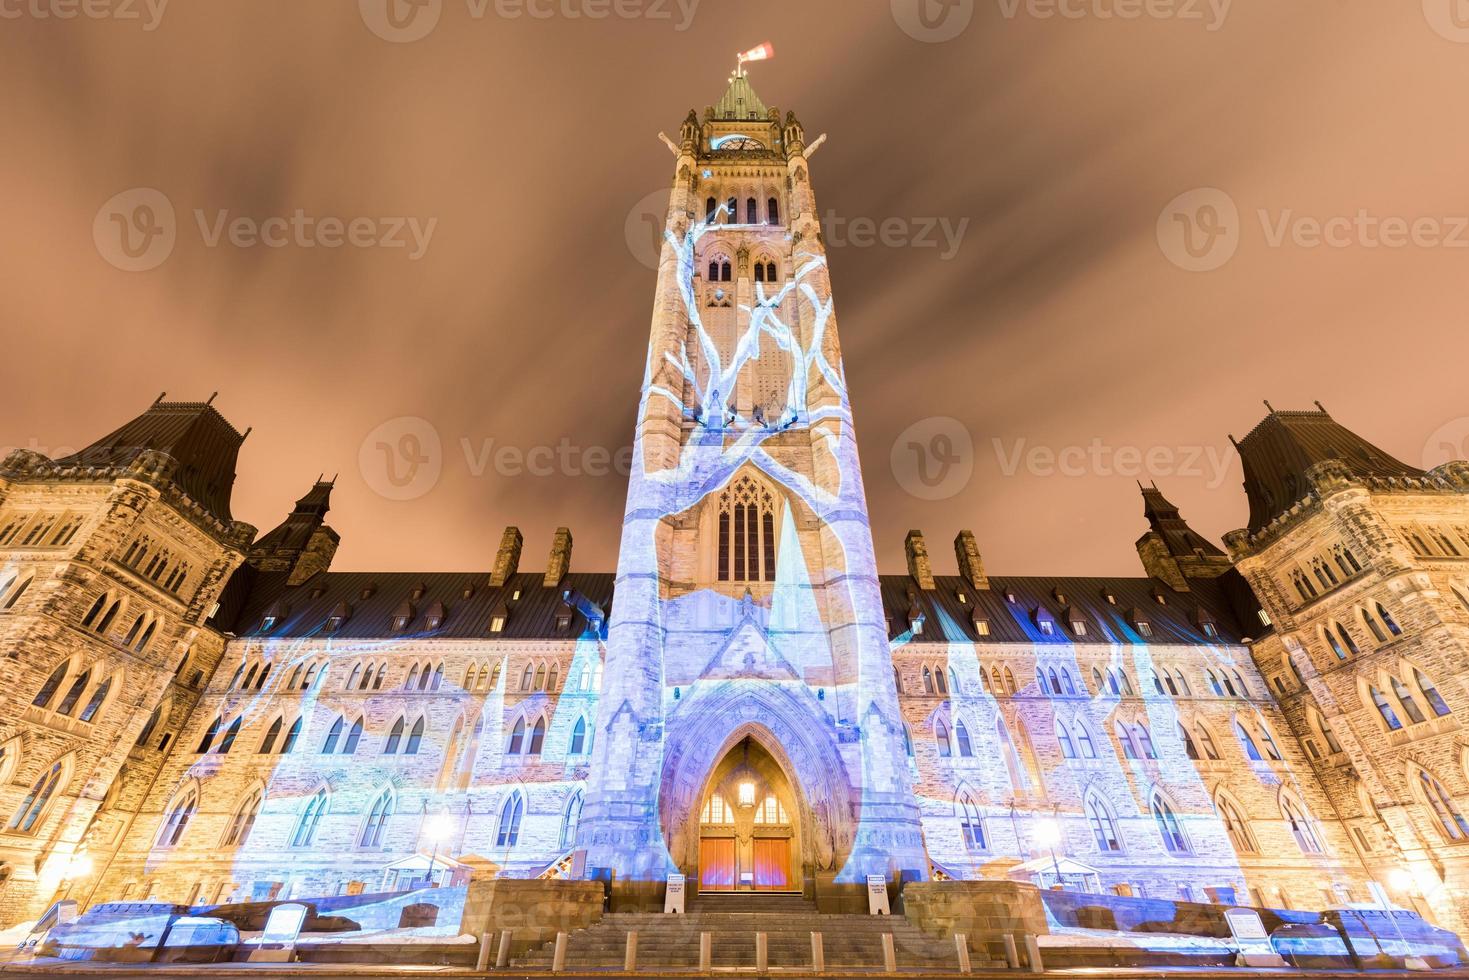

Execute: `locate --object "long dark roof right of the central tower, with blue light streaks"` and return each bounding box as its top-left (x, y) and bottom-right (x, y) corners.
top-left (880, 574), bottom-right (1265, 646)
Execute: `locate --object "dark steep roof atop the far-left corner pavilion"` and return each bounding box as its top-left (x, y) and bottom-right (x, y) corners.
top-left (56, 395), bottom-right (245, 523)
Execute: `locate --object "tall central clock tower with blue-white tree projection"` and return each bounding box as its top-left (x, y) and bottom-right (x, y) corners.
top-left (582, 71), bottom-right (927, 908)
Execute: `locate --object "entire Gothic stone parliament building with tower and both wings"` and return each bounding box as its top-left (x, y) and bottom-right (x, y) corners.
top-left (0, 72), bottom-right (1469, 930)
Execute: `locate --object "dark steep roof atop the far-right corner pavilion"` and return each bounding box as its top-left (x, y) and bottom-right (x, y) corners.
top-left (1235, 403), bottom-right (1425, 532)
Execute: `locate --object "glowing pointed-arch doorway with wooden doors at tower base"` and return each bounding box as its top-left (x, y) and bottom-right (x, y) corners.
top-left (698, 735), bottom-right (802, 892)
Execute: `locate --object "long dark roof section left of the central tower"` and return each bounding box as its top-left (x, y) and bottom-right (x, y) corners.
top-left (227, 572), bottom-right (616, 639)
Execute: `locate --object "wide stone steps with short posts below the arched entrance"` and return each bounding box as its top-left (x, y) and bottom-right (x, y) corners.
top-left (514, 892), bottom-right (1003, 973)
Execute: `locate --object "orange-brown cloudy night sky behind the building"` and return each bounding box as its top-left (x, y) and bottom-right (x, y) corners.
top-left (0, 0), bottom-right (1469, 574)
